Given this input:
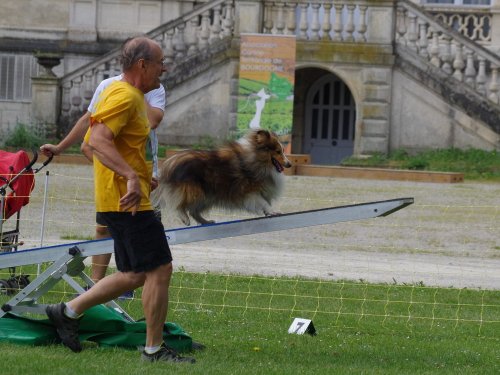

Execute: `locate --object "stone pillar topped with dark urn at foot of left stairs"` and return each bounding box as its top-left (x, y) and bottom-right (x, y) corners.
top-left (31, 53), bottom-right (61, 136)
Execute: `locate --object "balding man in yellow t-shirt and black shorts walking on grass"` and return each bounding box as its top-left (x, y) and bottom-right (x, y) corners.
top-left (46, 37), bottom-right (195, 363)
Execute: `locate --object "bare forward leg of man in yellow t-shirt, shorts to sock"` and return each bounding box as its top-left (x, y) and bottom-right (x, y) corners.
top-left (142, 263), bottom-right (172, 346)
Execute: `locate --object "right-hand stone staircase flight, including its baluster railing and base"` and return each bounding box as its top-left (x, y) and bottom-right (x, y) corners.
top-left (395, 0), bottom-right (500, 148)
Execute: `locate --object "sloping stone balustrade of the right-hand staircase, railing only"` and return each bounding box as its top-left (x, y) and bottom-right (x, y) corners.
top-left (395, 0), bottom-right (500, 104)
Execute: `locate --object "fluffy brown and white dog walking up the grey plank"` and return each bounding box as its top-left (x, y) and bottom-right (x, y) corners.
top-left (157, 129), bottom-right (292, 225)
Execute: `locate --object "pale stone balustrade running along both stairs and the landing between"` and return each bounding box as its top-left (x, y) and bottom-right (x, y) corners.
top-left (54, 0), bottom-right (500, 132)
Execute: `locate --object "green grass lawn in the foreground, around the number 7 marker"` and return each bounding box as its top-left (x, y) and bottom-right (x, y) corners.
top-left (0, 271), bottom-right (500, 375)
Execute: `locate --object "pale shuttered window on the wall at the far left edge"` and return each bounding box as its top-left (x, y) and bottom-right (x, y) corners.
top-left (0, 53), bottom-right (39, 101)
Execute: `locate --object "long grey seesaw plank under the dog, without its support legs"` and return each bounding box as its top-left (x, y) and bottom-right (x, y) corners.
top-left (0, 198), bottom-right (413, 269)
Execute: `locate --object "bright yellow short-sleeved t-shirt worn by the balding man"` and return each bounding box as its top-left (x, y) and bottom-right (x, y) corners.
top-left (85, 81), bottom-right (152, 212)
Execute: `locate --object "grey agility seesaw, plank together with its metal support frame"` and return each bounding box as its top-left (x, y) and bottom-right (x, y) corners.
top-left (0, 198), bottom-right (413, 321)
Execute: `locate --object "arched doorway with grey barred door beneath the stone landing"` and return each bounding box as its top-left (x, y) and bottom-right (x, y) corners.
top-left (303, 74), bottom-right (356, 164)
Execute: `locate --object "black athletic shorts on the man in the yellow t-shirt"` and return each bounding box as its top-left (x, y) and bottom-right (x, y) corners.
top-left (97, 211), bottom-right (172, 272)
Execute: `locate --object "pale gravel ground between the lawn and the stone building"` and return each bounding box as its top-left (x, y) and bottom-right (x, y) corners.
top-left (4, 163), bottom-right (500, 289)
